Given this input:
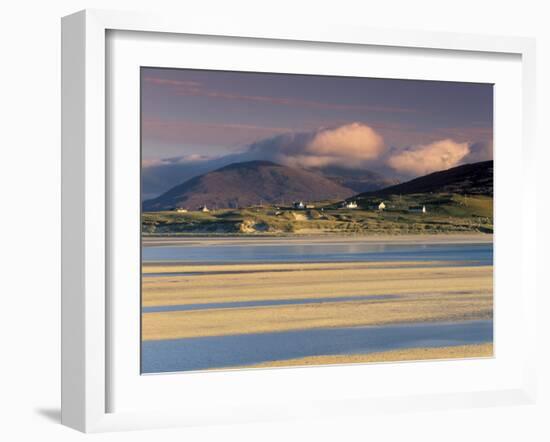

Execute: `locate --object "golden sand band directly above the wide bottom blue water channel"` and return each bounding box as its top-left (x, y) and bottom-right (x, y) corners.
top-left (142, 294), bottom-right (493, 340)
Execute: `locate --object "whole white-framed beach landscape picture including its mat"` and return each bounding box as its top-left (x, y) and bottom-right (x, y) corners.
top-left (62, 11), bottom-right (537, 432)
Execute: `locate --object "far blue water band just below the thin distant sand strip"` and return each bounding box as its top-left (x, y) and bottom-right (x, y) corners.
top-left (142, 242), bottom-right (493, 265)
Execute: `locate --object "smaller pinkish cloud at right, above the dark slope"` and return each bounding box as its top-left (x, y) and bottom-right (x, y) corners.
top-left (388, 139), bottom-right (470, 175)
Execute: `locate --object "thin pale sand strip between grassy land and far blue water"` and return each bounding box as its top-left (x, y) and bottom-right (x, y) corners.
top-left (142, 233), bottom-right (493, 247)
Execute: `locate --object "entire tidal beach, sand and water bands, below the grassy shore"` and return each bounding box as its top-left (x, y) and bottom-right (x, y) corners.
top-left (141, 234), bottom-right (493, 372)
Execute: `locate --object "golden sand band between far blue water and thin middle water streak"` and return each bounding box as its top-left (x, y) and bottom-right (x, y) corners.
top-left (142, 263), bottom-right (492, 307)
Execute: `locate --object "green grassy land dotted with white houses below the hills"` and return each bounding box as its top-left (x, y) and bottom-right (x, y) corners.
top-left (142, 193), bottom-right (493, 235)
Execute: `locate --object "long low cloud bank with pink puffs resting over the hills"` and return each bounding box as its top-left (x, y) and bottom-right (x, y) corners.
top-left (142, 123), bottom-right (493, 195)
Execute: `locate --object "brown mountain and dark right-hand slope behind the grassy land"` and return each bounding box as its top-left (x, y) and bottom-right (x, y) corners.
top-left (143, 161), bottom-right (493, 211)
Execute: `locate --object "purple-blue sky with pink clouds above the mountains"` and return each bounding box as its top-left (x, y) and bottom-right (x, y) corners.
top-left (141, 68), bottom-right (493, 197)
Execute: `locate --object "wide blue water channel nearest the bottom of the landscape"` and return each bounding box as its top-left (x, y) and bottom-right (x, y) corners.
top-left (141, 321), bottom-right (493, 373)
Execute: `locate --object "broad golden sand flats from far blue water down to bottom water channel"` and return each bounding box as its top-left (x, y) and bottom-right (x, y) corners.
top-left (142, 263), bottom-right (492, 340)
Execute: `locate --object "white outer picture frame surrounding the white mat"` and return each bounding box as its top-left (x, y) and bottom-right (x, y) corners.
top-left (62, 10), bottom-right (537, 432)
